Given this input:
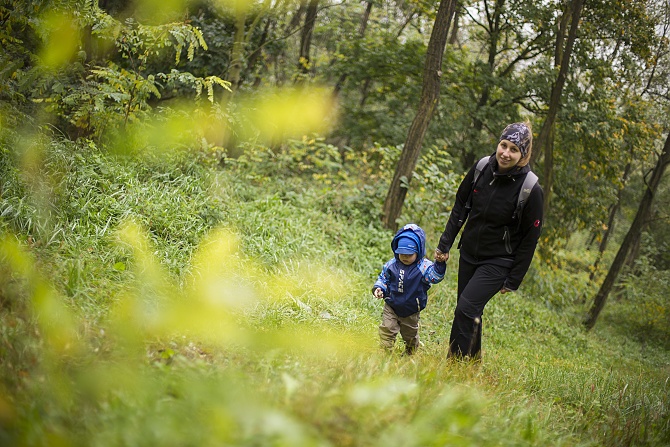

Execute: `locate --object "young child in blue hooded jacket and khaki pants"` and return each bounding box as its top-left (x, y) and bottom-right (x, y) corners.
top-left (372, 224), bottom-right (447, 354)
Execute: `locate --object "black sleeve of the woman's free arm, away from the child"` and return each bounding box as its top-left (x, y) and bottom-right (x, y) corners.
top-left (504, 183), bottom-right (544, 290)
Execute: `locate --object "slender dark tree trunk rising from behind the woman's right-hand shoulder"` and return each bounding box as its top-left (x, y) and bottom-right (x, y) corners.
top-left (532, 0), bottom-right (584, 216)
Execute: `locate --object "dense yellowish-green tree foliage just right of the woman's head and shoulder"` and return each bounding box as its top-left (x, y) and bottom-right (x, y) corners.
top-left (546, 49), bottom-right (660, 245)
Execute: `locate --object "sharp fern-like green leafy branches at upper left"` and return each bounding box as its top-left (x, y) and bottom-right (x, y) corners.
top-left (53, 11), bottom-right (229, 138)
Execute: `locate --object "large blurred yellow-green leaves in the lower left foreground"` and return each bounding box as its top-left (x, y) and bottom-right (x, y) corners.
top-left (0, 221), bottom-right (371, 445)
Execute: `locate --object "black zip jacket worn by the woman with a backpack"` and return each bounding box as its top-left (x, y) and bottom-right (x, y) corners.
top-left (437, 155), bottom-right (544, 290)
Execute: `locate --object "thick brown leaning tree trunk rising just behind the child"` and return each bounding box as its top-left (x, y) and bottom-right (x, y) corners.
top-left (382, 0), bottom-right (457, 230)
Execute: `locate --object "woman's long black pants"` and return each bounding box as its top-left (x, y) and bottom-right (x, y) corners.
top-left (449, 256), bottom-right (510, 358)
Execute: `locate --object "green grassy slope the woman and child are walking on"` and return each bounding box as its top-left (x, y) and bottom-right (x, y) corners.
top-left (0, 140), bottom-right (670, 446)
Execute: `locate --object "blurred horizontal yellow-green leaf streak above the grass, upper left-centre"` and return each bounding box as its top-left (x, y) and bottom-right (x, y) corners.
top-left (103, 85), bottom-right (337, 155)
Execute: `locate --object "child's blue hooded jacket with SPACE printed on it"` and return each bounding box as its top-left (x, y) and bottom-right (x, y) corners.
top-left (372, 224), bottom-right (447, 317)
